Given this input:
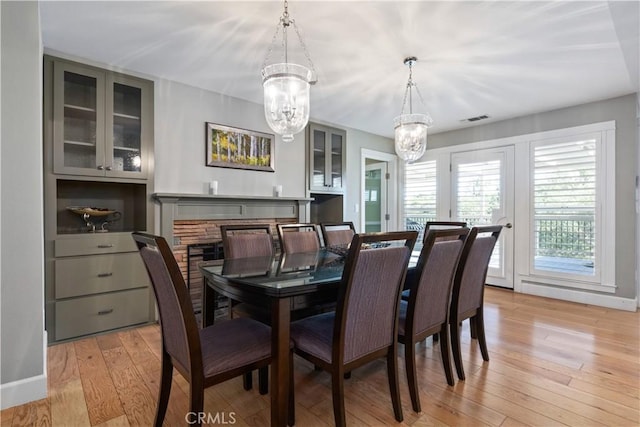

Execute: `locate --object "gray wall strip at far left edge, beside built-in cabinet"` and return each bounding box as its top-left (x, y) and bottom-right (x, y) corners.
top-left (0, 1), bottom-right (46, 407)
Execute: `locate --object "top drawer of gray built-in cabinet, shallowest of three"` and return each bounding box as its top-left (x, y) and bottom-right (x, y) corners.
top-left (55, 233), bottom-right (138, 257)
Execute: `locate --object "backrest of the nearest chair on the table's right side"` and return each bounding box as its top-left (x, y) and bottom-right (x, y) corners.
top-left (332, 231), bottom-right (418, 364)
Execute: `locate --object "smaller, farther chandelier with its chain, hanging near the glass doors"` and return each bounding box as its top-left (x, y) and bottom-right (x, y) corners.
top-left (393, 56), bottom-right (433, 163)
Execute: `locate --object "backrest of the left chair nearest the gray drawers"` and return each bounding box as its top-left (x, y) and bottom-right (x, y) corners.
top-left (132, 232), bottom-right (202, 378)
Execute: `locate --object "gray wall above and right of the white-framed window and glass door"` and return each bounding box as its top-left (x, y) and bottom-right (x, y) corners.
top-left (429, 94), bottom-right (639, 298)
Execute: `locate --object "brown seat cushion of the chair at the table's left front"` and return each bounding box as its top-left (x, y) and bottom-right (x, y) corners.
top-left (200, 318), bottom-right (271, 377)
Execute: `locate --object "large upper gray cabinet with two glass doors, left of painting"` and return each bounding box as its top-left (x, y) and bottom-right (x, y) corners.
top-left (52, 60), bottom-right (153, 179)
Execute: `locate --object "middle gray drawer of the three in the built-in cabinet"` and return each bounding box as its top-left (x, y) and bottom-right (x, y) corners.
top-left (55, 252), bottom-right (149, 299)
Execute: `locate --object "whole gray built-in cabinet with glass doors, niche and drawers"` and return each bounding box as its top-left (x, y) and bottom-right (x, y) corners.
top-left (43, 56), bottom-right (155, 343)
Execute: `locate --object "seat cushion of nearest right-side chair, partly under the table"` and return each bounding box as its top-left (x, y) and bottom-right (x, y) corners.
top-left (291, 312), bottom-right (336, 363)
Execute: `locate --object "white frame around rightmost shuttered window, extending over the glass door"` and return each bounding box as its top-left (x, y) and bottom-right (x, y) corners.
top-left (408, 120), bottom-right (616, 297)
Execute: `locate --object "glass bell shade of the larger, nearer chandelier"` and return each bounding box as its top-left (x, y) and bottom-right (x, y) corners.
top-left (262, 63), bottom-right (312, 142)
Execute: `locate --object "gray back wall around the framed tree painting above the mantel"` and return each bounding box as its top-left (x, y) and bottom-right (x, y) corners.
top-left (153, 77), bottom-right (394, 234)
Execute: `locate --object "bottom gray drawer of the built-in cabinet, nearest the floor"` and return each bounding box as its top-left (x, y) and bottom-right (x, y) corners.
top-left (55, 288), bottom-right (150, 340)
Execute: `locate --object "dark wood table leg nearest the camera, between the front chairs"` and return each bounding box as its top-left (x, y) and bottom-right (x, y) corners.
top-left (271, 298), bottom-right (293, 427)
